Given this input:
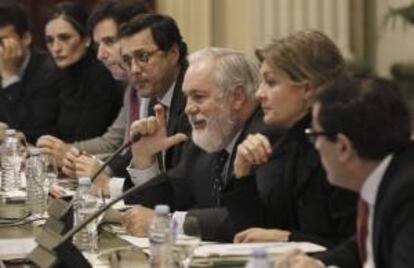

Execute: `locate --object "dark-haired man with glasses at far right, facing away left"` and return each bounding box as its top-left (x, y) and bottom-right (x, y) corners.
top-left (279, 77), bottom-right (414, 268)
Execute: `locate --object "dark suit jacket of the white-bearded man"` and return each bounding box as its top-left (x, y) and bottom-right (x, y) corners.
top-left (124, 109), bottom-right (280, 241)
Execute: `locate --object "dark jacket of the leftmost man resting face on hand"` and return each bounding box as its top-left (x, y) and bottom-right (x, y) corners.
top-left (0, 49), bottom-right (61, 143)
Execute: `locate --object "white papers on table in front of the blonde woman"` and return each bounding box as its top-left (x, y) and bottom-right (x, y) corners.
top-left (194, 242), bottom-right (326, 257)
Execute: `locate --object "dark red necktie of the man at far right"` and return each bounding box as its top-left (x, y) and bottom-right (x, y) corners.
top-left (357, 197), bottom-right (369, 264)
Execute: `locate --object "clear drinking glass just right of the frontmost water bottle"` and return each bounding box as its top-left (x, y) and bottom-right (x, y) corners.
top-left (173, 216), bottom-right (201, 268)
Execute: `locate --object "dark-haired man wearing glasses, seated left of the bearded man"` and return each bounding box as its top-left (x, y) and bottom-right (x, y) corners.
top-left (75, 14), bottom-right (190, 199)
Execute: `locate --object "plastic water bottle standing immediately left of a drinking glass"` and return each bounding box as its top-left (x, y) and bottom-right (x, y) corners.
top-left (148, 205), bottom-right (173, 268)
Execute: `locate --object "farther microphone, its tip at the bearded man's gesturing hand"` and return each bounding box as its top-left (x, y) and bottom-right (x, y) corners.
top-left (44, 132), bottom-right (142, 234)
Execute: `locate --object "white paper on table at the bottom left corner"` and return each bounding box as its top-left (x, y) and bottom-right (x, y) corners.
top-left (0, 238), bottom-right (36, 260)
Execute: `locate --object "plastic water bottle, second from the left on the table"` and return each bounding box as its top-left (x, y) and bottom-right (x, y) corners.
top-left (26, 148), bottom-right (48, 217)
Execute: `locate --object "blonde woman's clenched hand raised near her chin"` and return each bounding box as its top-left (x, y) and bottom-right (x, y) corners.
top-left (234, 134), bottom-right (272, 178)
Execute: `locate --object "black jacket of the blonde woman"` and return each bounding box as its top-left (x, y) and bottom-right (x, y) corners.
top-left (223, 115), bottom-right (357, 247)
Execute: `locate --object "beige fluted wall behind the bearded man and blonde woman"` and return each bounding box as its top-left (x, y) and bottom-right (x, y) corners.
top-left (157, 0), bottom-right (363, 59)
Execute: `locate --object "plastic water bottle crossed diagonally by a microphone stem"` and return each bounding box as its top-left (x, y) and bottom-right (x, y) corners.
top-left (73, 177), bottom-right (99, 252)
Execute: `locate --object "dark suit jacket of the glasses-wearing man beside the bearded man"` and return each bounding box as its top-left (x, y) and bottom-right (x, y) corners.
top-left (118, 66), bottom-right (191, 182)
